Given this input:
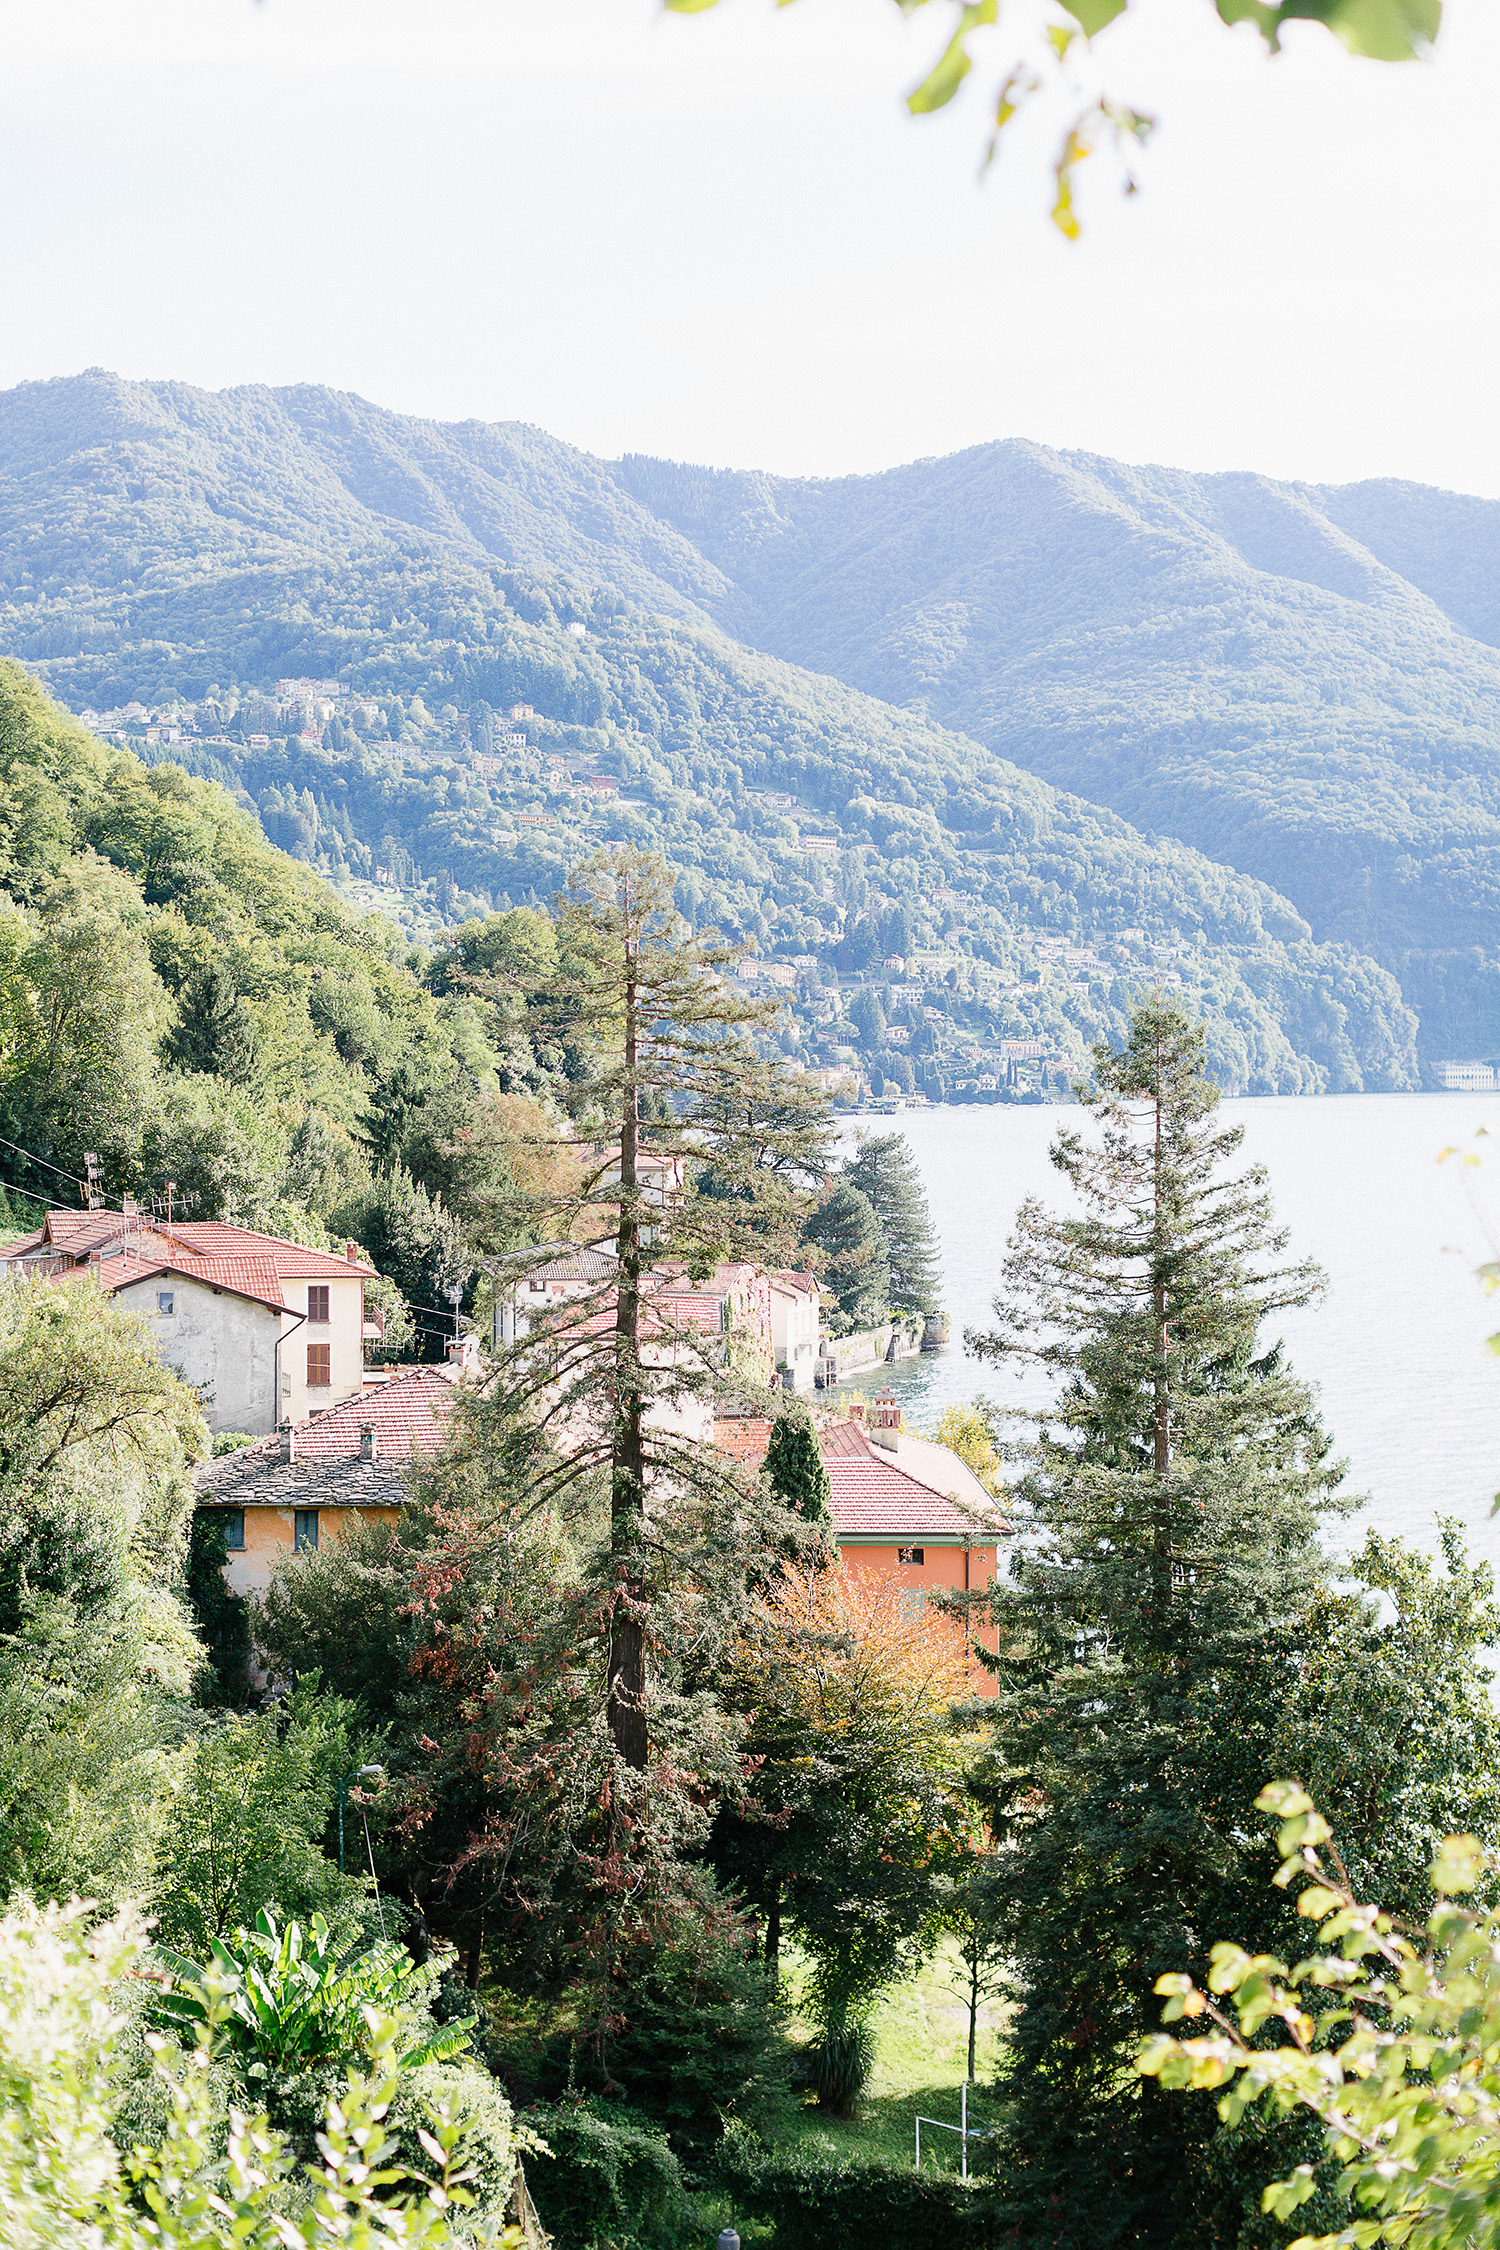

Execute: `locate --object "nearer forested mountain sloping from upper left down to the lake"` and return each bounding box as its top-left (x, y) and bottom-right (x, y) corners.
top-left (0, 378), bottom-right (1430, 1098)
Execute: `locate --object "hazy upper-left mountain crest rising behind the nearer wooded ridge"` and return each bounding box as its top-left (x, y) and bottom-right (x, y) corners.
top-left (0, 369), bottom-right (729, 634)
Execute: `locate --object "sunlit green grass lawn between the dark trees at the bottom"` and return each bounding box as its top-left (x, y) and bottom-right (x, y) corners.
top-left (787, 1940), bottom-right (1003, 2171)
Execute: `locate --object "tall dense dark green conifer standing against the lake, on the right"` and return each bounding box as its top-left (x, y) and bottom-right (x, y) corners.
top-left (969, 999), bottom-right (1340, 2250)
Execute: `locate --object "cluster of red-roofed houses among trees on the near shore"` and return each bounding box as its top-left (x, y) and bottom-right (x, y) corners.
top-left (0, 1197), bottom-right (1007, 1692)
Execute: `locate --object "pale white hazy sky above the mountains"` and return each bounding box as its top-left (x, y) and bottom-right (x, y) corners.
top-left (0, 0), bottom-right (1500, 495)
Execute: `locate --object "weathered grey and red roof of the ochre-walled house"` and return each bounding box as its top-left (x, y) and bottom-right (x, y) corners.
top-left (198, 1368), bottom-right (457, 1508)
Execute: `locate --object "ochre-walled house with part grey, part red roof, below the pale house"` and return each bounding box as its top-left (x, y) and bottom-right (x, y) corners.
top-left (198, 1368), bottom-right (457, 1593)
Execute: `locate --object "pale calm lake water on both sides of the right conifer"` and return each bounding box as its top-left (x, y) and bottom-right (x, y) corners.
top-left (846, 1094), bottom-right (1500, 1566)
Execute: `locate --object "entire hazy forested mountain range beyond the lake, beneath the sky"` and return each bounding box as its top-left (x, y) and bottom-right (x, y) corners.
top-left (0, 371), bottom-right (1457, 1089)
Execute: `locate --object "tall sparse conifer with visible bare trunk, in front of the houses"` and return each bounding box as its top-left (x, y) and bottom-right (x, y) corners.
top-left (472, 851), bottom-right (828, 1773)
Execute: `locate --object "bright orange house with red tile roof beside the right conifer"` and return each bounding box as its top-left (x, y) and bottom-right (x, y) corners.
top-left (713, 1415), bottom-right (1010, 1694)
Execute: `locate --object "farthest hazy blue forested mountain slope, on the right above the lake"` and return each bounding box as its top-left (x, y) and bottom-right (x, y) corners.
top-left (618, 443), bottom-right (1500, 1051)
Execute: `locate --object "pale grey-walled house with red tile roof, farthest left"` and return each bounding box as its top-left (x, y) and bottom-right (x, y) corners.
top-left (7, 1206), bottom-right (376, 1436)
